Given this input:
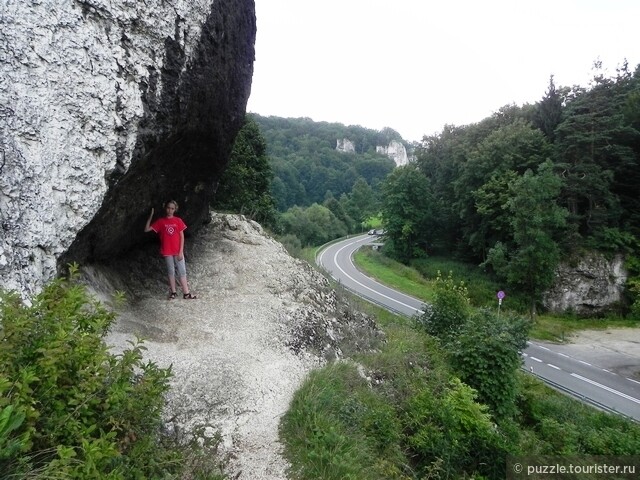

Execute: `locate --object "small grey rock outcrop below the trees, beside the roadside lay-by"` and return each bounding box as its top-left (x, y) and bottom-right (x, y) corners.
top-left (543, 254), bottom-right (627, 316)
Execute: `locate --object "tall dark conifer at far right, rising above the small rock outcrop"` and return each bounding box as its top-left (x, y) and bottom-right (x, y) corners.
top-left (555, 72), bottom-right (639, 237)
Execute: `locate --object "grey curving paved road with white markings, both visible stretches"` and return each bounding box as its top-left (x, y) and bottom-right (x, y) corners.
top-left (317, 235), bottom-right (640, 421)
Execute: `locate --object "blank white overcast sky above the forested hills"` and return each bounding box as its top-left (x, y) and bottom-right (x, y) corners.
top-left (247, 0), bottom-right (640, 141)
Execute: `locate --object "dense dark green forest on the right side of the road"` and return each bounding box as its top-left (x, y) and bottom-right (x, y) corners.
top-left (382, 64), bottom-right (640, 316)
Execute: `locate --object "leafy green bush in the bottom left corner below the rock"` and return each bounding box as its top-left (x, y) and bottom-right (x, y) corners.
top-left (0, 267), bottom-right (225, 479)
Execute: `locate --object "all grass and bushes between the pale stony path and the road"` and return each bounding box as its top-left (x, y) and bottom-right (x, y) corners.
top-left (280, 292), bottom-right (640, 480)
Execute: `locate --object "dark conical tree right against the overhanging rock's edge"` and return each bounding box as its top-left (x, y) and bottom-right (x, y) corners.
top-left (214, 116), bottom-right (275, 224)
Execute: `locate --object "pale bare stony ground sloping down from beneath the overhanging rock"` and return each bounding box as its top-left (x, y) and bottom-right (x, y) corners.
top-left (85, 213), bottom-right (381, 480)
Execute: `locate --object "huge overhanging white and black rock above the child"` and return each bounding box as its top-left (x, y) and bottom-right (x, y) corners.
top-left (0, 0), bottom-right (256, 294)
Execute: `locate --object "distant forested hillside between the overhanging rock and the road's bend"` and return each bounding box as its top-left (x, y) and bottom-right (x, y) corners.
top-left (213, 114), bottom-right (411, 250)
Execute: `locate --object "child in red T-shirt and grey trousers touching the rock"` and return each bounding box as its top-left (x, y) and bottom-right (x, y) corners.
top-left (144, 200), bottom-right (196, 300)
